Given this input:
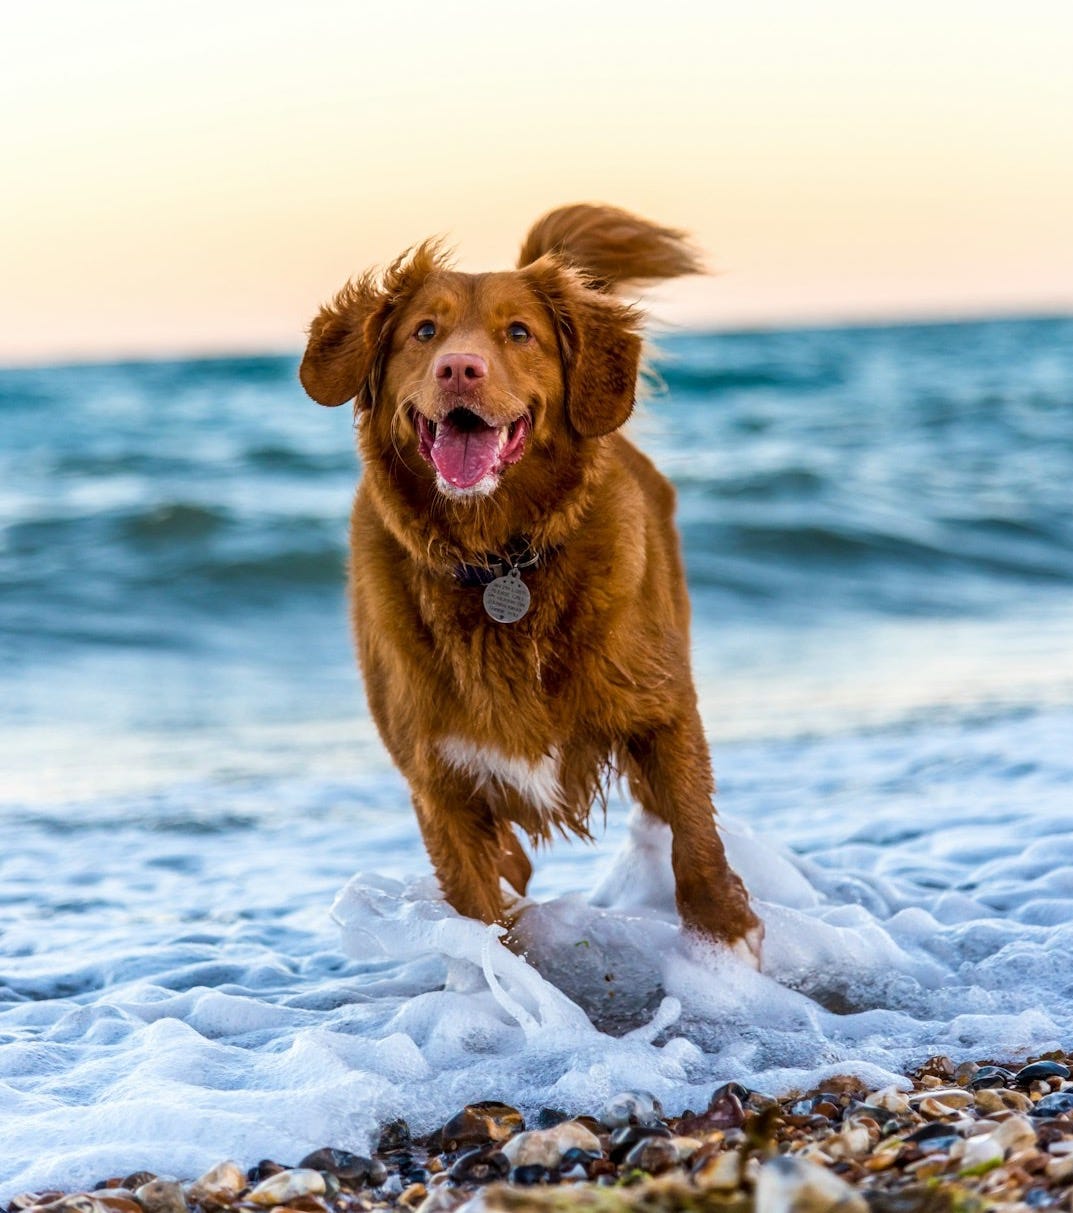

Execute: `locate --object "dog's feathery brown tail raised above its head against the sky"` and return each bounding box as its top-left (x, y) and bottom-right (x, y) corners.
top-left (518, 203), bottom-right (704, 291)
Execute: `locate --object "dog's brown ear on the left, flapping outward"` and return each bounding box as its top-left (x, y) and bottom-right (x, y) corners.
top-left (298, 272), bottom-right (392, 409)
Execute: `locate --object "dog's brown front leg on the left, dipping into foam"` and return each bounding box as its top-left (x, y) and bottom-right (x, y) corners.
top-left (413, 773), bottom-right (504, 923)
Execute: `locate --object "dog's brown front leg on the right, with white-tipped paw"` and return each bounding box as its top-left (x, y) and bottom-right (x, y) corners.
top-left (628, 713), bottom-right (764, 966)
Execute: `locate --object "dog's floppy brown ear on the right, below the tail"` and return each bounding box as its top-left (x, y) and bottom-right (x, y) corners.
top-left (521, 256), bottom-right (641, 438)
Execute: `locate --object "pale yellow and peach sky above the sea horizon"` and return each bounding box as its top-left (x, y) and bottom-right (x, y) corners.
top-left (0, 0), bottom-right (1073, 364)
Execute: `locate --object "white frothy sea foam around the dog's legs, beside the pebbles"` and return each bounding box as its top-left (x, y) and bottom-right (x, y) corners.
top-left (0, 711), bottom-right (1073, 1198)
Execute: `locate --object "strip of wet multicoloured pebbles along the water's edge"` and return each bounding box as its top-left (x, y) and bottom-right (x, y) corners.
top-left (6, 1052), bottom-right (1073, 1213)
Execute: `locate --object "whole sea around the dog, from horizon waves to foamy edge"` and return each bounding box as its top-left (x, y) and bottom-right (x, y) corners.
top-left (0, 319), bottom-right (1073, 1198)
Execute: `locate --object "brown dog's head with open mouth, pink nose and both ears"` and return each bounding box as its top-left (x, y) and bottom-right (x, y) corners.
top-left (299, 244), bottom-right (641, 499)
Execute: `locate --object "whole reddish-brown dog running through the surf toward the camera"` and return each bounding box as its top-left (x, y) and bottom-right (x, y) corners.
top-left (299, 205), bottom-right (763, 958)
